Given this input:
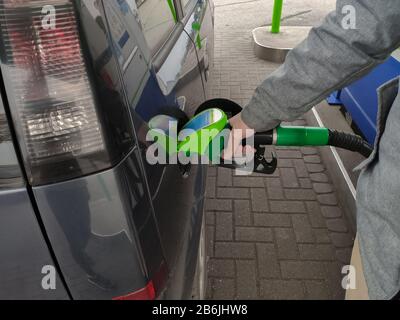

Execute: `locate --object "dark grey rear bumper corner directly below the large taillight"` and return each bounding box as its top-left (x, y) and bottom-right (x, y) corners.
top-left (33, 150), bottom-right (162, 299)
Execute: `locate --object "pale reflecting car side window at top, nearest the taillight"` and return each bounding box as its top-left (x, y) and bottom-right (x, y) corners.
top-left (136, 0), bottom-right (176, 54)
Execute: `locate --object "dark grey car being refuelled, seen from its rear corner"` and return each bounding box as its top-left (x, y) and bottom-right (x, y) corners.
top-left (0, 0), bottom-right (213, 299)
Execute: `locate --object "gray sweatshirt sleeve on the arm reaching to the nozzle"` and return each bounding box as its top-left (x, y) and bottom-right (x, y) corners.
top-left (242, 0), bottom-right (400, 131)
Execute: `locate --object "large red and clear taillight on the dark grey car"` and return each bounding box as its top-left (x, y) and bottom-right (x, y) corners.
top-left (0, 0), bottom-right (107, 185)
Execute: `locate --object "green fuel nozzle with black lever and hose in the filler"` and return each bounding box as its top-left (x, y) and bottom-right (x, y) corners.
top-left (149, 108), bottom-right (373, 174)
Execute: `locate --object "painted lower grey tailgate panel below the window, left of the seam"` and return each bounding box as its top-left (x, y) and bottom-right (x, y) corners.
top-left (0, 188), bottom-right (69, 300)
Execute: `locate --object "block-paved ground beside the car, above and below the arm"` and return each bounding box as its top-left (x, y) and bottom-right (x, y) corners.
top-left (206, 0), bottom-right (354, 299)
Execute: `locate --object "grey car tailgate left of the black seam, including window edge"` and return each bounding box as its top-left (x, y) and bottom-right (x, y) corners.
top-left (0, 89), bottom-right (69, 300)
